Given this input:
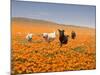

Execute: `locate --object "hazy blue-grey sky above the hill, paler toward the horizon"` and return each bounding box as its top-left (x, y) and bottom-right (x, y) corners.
top-left (11, 0), bottom-right (96, 28)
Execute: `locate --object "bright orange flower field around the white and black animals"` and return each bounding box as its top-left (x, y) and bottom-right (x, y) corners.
top-left (11, 18), bottom-right (96, 75)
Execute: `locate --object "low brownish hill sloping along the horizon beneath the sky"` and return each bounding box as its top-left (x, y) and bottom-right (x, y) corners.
top-left (12, 17), bottom-right (94, 28)
